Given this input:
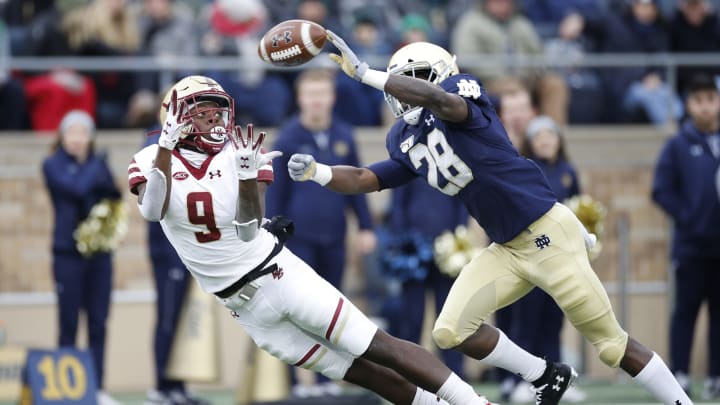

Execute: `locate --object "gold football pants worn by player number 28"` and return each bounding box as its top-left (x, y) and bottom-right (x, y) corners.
top-left (433, 203), bottom-right (628, 367)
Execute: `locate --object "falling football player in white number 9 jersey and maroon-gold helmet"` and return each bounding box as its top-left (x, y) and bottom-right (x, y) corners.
top-left (128, 76), bottom-right (496, 405)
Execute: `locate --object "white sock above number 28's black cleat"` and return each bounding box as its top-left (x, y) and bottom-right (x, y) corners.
top-left (480, 329), bottom-right (546, 382)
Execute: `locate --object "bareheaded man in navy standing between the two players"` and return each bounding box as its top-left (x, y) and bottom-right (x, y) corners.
top-left (266, 69), bottom-right (376, 396)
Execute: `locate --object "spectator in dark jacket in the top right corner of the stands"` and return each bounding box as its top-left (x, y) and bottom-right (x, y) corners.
top-left (670, 0), bottom-right (720, 92)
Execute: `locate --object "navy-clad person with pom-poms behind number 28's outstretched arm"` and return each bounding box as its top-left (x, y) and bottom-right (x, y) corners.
top-left (387, 179), bottom-right (469, 378)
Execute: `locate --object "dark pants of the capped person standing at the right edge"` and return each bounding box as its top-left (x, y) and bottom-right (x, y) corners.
top-left (670, 258), bottom-right (720, 377)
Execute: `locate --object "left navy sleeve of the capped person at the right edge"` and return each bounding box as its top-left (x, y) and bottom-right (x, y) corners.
top-left (652, 142), bottom-right (682, 222)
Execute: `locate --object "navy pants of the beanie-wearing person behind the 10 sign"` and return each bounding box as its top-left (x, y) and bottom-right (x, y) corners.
top-left (53, 253), bottom-right (112, 388)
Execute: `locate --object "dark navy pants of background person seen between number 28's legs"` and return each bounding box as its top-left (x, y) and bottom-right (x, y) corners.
top-left (509, 288), bottom-right (564, 382)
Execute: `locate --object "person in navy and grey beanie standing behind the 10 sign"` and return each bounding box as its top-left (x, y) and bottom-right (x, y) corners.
top-left (43, 111), bottom-right (120, 405)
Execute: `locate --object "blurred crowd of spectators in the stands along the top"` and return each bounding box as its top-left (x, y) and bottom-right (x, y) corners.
top-left (0, 0), bottom-right (720, 131)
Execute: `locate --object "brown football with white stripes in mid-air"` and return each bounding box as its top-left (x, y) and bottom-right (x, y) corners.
top-left (258, 20), bottom-right (327, 66)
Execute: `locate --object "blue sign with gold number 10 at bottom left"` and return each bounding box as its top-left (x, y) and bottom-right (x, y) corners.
top-left (20, 348), bottom-right (97, 405)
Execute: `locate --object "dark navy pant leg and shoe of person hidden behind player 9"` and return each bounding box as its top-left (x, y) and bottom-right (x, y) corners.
top-left (151, 255), bottom-right (190, 392)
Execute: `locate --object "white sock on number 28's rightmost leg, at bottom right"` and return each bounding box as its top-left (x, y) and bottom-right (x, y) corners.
top-left (633, 352), bottom-right (693, 405)
